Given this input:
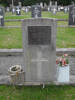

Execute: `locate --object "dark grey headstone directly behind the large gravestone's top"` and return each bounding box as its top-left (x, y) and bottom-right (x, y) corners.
top-left (32, 5), bottom-right (41, 18)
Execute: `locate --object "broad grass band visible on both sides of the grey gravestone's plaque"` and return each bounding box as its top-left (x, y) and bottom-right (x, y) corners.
top-left (0, 26), bottom-right (75, 49)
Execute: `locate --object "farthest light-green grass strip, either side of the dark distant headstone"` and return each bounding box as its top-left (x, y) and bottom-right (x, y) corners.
top-left (5, 11), bottom-right (69, 19)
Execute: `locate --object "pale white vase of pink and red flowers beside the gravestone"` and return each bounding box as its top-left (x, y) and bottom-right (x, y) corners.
top-left (56, 54), bottom-right (70, 83)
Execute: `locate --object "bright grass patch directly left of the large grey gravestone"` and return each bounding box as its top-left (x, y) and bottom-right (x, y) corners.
top-left (0, 28), bottom-right (22, 49)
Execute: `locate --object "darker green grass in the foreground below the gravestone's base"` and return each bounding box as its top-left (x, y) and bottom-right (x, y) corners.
top-left (0, 86), bottom-right (75, 100)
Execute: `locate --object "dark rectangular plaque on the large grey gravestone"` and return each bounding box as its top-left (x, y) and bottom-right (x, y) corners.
top-left (28, 26), bottom-right (51, 45)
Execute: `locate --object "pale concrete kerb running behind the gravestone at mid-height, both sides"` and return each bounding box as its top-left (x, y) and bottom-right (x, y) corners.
top-left (0, 48), bottom-right (75, 56)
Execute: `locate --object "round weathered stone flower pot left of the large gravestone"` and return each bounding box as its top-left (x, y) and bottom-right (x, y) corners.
top-left (8, 65), bottom-right (25, 85)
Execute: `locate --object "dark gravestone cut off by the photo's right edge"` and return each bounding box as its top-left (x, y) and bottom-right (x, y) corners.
top-left (69, 5), bottom-right (75, 25)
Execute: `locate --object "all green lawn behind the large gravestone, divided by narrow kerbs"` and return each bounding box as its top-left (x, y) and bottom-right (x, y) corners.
top-left (0, 12), bottom-right (75, 48)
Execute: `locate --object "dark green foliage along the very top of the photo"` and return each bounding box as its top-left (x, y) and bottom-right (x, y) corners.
top-left (0, 0), bottom-right (75, 6)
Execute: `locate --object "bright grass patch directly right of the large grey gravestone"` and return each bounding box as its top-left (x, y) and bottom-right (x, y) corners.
top-left (56, 28), bottom-right (75, 48)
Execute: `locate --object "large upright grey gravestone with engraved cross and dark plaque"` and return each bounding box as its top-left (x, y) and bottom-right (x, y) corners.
top-left (22, 18), bottom-right (57, 83)
